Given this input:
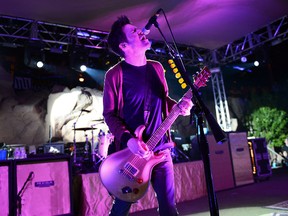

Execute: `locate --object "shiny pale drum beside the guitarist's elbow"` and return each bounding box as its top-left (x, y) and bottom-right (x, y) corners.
top-left (97, 130), bottom-right (114, 158)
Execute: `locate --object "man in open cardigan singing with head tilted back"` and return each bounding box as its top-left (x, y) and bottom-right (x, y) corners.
top-left (103, 16), bottom-right (193, 216)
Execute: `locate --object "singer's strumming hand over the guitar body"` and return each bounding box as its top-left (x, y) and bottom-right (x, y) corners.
top-left (127, 138), bottom-right (151, 158)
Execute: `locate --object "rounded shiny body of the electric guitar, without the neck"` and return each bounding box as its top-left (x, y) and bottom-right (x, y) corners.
top-left (99, 148), bottom-right (168, 202)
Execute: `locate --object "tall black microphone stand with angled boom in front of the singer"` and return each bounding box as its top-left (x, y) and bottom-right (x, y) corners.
top-left (154, 10), bottom-right (226, 216)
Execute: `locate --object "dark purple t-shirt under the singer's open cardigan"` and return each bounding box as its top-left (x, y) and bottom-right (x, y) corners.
top-left (121, 61), bottom-right (167, 147)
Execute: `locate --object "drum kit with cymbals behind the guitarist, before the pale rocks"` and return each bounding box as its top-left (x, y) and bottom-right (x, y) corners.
top-left (72, 119), bottom-right (114, 170)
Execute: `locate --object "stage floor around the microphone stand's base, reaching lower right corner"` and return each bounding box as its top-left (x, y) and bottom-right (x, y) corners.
top-left (130, 168), bottom-right (288, 216)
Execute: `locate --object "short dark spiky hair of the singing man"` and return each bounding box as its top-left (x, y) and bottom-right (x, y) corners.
top-left (108, 16), bottom-right (131, 57)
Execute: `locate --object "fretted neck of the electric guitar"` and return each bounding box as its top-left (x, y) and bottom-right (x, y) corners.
top-left (146, 89), bottom-right (192, 150)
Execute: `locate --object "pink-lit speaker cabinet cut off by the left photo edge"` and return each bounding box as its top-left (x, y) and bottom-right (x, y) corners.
top-left (0, 161), bottom-right (12, 215)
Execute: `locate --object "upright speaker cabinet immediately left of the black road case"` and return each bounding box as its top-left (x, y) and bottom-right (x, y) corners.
top-left (228, 132), bottom-right (254, 186)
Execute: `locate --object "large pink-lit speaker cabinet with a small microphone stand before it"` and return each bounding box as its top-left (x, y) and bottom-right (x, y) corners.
top-left (15, 157), bottom-right (72, 216)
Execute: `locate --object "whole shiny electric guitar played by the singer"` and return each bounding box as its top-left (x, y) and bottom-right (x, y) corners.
top-left (99, 67), bottom-right (211, 202)
